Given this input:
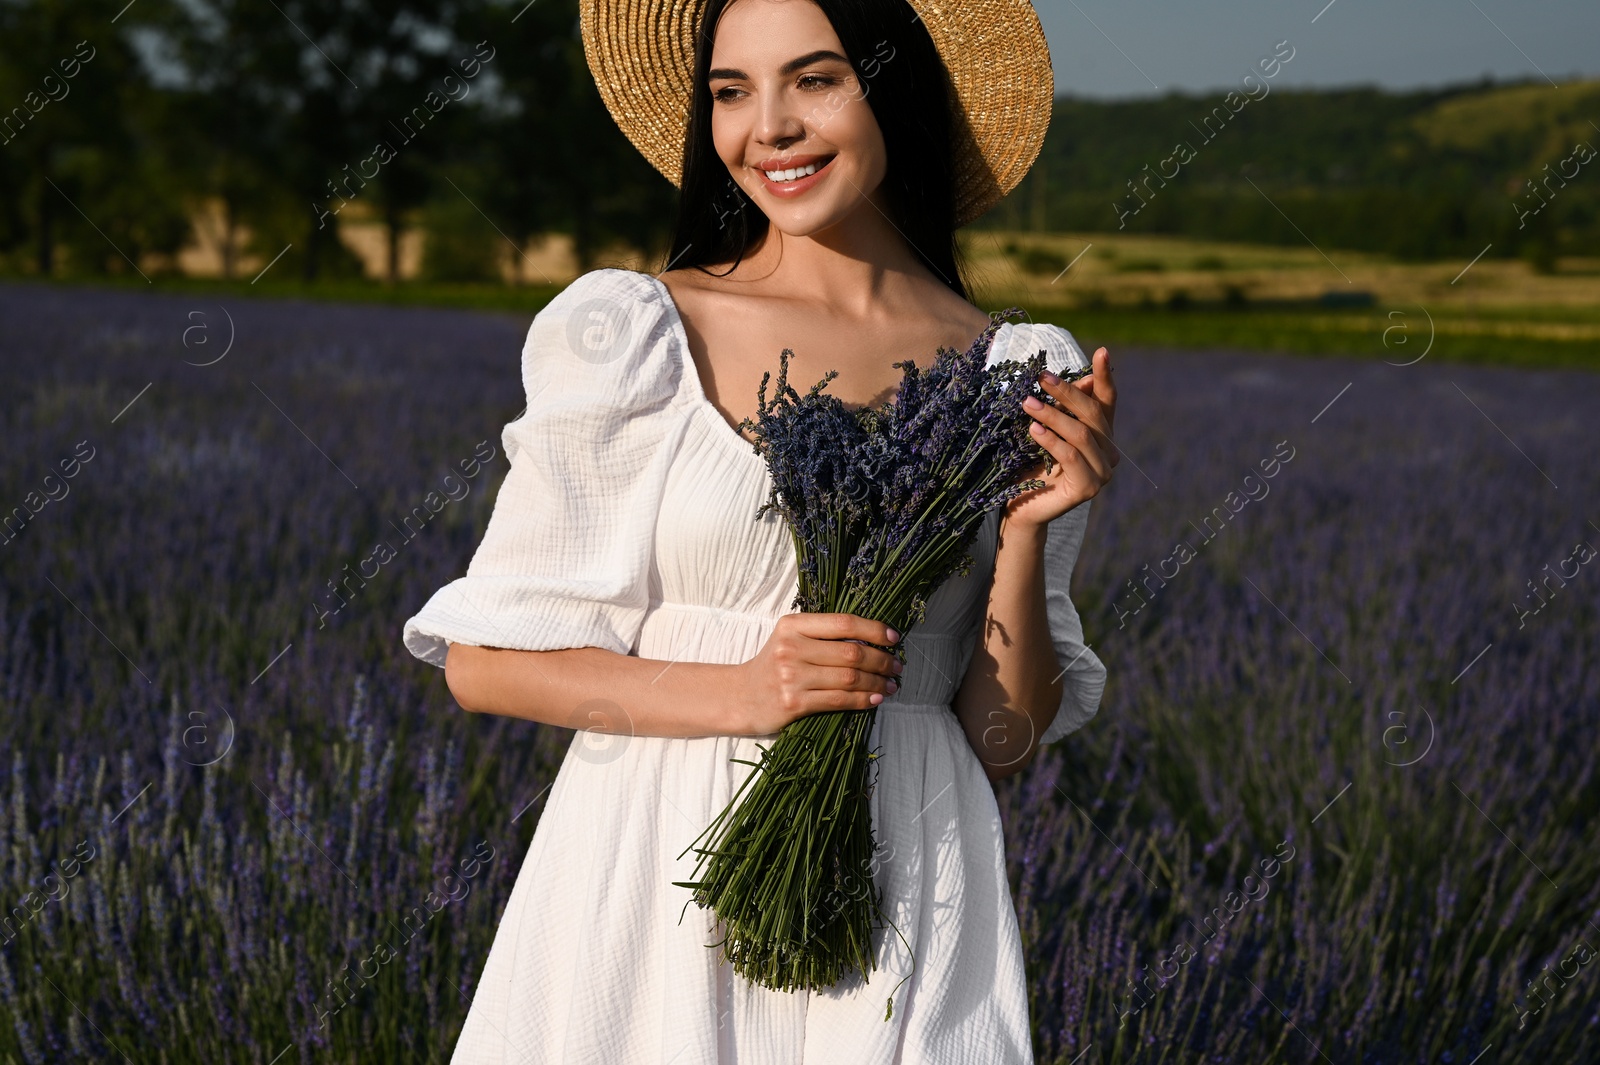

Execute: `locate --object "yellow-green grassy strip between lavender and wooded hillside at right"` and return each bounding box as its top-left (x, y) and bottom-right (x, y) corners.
top-left (965, 232), bottom-right (1600, 369)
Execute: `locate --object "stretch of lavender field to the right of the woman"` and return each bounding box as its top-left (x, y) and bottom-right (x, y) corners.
top-left (1002, 353), bottom-right (1600, 1063)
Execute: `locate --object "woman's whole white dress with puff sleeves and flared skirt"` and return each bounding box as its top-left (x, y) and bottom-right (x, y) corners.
top-left (405, 270), bottom-right (1106, 1065)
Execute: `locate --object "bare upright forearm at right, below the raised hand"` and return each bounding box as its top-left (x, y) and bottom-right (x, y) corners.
top-left (952, 521), bottom-right (1062, 780)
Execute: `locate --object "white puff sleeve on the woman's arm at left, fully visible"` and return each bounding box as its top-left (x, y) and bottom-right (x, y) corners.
top-left (403, 270), bottom-right (688, 667)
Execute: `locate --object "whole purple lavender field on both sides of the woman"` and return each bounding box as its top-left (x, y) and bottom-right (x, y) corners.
top-left (0, 285), bottom-right (1600, 1065)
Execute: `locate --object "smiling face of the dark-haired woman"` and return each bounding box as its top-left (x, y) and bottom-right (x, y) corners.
top-left (710, 0), bottom-right (888, 237)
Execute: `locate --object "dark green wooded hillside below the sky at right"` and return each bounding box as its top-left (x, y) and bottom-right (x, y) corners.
top-left (987, 82), bottom-right (1600, 269)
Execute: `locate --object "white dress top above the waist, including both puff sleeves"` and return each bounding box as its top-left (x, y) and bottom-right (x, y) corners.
top-left (406, 270), bottom-right (1104, 740)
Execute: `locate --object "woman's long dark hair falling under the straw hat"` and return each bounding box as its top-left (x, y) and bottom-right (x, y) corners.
top-left (667, 0), bottom-right (966, 299)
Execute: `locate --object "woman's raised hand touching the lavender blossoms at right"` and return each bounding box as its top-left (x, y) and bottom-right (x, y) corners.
top-left (1003, 347), bottom-right (1122, 526)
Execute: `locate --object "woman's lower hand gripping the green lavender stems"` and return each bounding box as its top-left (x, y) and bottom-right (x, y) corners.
top-left (731, 612), bottom-right (902, 736)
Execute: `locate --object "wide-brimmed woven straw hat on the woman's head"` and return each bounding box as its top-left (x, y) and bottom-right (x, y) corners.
top-left (579, 0), bottom-right (1054, 225)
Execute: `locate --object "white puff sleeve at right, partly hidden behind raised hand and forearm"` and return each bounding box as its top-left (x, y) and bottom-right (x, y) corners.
top-left (989, 323), bottom-right (1106, 745)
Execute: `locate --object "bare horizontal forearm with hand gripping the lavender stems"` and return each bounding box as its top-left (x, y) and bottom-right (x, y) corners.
top-left (445, 614), bottom-right (901, 737)
